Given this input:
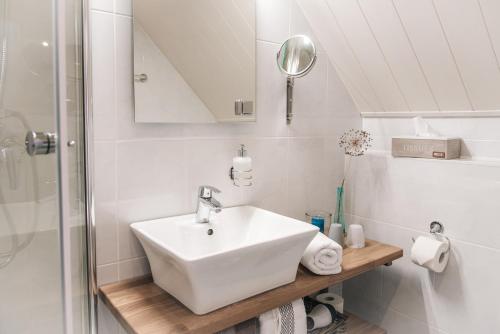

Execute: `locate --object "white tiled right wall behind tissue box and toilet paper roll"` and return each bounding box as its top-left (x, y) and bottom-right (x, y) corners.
top-left (344, 118), bottom-right (500, 334)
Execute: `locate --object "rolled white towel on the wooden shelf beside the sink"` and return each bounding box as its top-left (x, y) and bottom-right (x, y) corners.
top-left (300, 233), bottom-right (342, 275)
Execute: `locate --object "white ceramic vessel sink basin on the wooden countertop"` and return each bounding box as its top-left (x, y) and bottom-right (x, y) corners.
top-left (131, 206), bottom-right (318, 314)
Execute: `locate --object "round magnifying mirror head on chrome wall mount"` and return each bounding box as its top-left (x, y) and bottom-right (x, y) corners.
top-left (277, 35), bottom-right (316, 78)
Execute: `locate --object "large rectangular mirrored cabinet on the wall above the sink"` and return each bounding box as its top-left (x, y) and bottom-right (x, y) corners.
top-left (133, 0), bottom-right (256, 123)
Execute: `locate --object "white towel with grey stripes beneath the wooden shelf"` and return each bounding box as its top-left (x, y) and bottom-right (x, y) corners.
top-left (259, 298), bottom-right (307, 334)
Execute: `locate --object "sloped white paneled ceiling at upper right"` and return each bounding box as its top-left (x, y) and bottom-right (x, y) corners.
top-left (297, 0), bottom-right (500, 116)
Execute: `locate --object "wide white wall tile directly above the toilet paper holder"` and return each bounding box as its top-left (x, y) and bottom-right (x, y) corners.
top-left (348, 155), bottom-right (500, 247)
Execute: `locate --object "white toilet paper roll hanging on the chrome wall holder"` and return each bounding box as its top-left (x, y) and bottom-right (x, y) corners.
top-left (411, 236), bottom-right (450, 273)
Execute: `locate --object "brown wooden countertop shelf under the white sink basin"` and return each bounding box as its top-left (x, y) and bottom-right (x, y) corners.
top-left (99, 240), bottom-right (403, 334)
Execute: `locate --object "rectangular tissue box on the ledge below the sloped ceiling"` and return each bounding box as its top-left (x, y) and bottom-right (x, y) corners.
top-left (392, 137), bottom-right (461, 160)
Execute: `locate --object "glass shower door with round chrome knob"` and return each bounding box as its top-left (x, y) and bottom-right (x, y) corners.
top-left (0, 0), bottom-right (88, 334)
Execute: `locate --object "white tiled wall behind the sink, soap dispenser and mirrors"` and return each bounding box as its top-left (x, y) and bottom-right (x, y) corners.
top-left (92, 0), bottom-right (360, 333)
